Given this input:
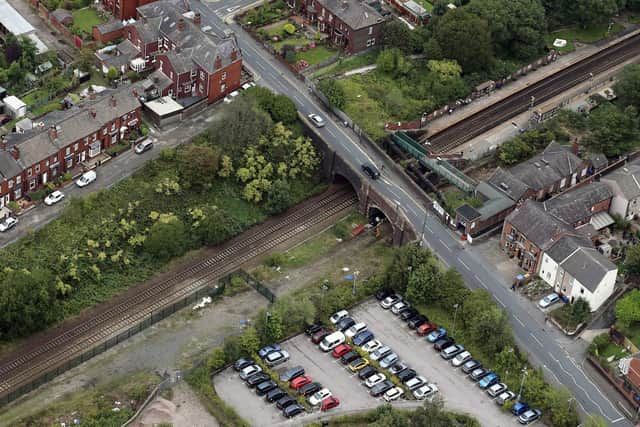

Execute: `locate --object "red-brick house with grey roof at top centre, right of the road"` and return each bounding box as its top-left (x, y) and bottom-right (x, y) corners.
top-left (302, 0), bottom-right (387, 53)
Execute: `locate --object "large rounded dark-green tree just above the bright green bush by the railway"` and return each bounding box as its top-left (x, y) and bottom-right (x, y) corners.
top-left (433, 8), bottom-right (494, 73)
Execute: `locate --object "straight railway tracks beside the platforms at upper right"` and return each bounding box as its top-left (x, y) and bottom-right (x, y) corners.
top-left (427, 35), bottom-right (640, 153)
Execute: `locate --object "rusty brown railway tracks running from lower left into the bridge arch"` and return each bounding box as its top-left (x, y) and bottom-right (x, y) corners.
top-left (0, 188), bottom-right (357, 399)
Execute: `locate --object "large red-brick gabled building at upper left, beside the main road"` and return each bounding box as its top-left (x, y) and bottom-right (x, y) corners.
top-left (96, 0), bottom-right (242, 103)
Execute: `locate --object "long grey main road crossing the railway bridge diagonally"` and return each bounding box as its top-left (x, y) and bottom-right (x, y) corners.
top-left (191, 0), bottom-right (632, 426)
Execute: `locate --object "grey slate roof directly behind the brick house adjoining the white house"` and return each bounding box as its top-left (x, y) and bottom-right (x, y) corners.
top-left (544, 182), bottom-right (613, 224)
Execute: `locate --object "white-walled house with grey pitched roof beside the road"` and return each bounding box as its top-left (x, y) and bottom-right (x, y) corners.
top-left (538, 236), bottom-right (618, 311)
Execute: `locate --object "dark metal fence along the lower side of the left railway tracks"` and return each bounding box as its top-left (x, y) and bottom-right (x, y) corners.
top-left (0, 283), bottom-right (225, 405)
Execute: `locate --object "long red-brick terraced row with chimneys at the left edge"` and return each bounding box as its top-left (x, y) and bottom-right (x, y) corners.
top-left (0, 91), bottom-right (141, 208)
